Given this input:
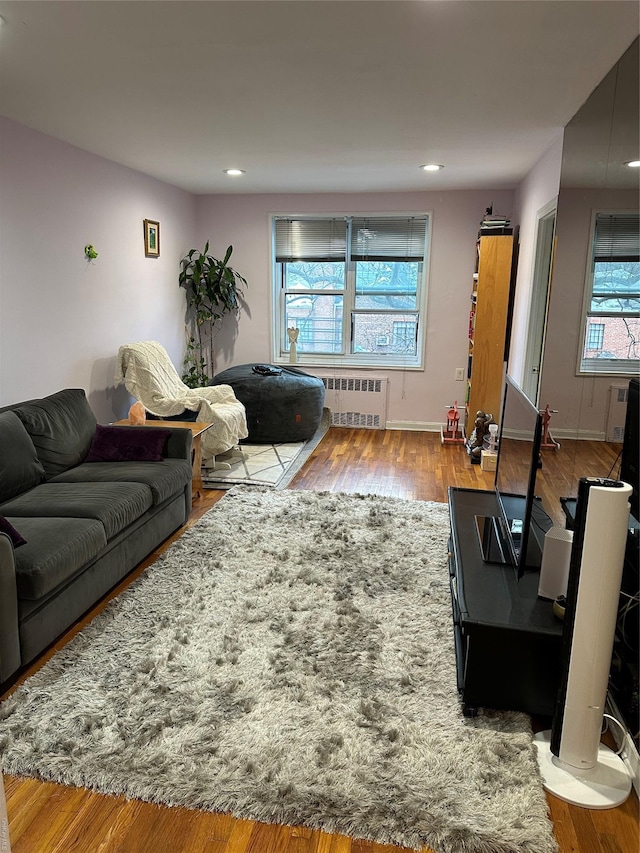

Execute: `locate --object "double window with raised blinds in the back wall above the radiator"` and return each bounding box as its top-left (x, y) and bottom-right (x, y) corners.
top-left (273, 214), bottom-right (428, 367)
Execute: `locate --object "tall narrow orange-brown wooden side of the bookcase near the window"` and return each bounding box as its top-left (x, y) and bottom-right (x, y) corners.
top-left (466, 229), bottom-right (513, 436)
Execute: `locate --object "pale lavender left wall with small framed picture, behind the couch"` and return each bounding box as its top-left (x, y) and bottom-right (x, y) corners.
top-left (0, 117), bottom-right (195, 421)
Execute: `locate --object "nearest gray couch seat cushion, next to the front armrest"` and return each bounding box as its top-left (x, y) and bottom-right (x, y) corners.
top-left (10, 516), bottom-right (107, 601)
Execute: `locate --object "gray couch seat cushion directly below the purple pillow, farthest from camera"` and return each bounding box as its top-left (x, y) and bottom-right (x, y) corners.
top-left (49, 459), bottom-right (192, 506)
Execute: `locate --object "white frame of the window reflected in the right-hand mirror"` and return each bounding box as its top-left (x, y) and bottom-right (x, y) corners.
top-left (576, 208), bottom-right (640, 376)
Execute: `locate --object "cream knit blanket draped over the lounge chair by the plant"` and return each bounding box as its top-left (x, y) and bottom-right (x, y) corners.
top-left (114, 341), bottom-right (249, 459)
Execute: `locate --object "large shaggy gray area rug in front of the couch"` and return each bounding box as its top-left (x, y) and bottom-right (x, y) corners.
top-left (0, 487), bottom-right (557, 853)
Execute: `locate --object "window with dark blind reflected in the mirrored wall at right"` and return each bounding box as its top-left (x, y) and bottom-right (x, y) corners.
top-left (580, 212), bottom-right (640, 374)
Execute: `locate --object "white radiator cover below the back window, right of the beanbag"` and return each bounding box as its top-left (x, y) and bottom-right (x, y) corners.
top-left (315, 373), bottom-right (389, 429)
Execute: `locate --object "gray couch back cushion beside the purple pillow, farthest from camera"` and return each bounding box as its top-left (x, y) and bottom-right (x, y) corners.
top-left (14, 388), bottom-right (96, 479)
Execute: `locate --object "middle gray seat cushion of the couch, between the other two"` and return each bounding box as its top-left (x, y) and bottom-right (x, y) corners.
top-left (0, 482), bottom-right (154, 539)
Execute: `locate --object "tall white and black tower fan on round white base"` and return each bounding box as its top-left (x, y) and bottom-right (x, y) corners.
top-left (535, 477), bottom-right (633, 809)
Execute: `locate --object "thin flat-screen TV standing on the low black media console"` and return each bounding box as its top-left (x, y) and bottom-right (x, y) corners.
top-left (476, 375), bottom-right (545, 578)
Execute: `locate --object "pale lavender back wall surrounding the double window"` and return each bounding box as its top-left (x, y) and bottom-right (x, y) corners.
top-left (197, 190), bottom-right (513, 429)
